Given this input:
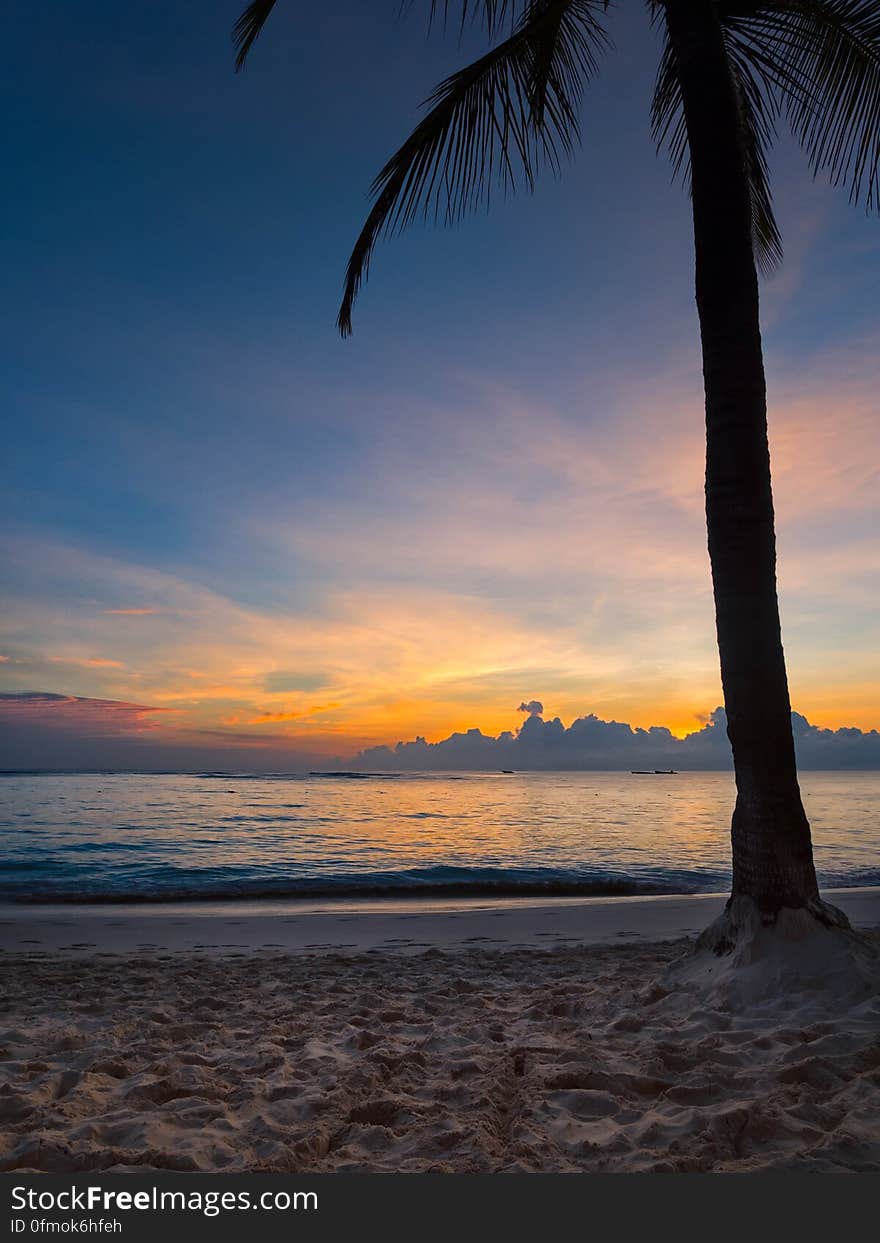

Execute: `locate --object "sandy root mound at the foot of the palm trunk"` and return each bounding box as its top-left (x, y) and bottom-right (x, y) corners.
top-left (669, 895), bottom-right (880, 1007)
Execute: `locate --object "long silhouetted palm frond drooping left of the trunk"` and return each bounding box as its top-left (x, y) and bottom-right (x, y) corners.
top-left (337, 0), bottom-right (608, 336)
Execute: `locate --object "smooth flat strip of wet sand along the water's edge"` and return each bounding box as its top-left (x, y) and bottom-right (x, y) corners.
top-left (0, 886), bottom-right (880, 961)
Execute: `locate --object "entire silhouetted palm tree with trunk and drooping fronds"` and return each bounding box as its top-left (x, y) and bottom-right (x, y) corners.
top-left (234, 0), bottom-right (880, 952)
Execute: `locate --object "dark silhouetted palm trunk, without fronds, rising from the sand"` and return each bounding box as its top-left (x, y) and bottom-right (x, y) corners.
top-left (666, 0), bottom-right (823, 921)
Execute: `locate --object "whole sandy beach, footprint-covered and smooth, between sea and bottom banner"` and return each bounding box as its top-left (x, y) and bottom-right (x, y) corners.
top-left (0, 890), bottom-right (880, 1172)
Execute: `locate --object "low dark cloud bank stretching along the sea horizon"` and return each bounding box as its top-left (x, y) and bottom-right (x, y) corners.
top-left (0, 692), bottom-right (880, 772)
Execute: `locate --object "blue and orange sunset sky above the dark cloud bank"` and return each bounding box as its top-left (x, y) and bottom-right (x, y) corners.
top-left (0, 0), bottom-right (880, 767)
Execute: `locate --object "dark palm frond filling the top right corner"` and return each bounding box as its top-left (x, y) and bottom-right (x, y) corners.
top-left (722, 0), bottom-right (880, 210)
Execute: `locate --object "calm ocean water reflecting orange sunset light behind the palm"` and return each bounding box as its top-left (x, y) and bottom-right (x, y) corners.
top-left (0, 772), bottom-right (880, 902)
